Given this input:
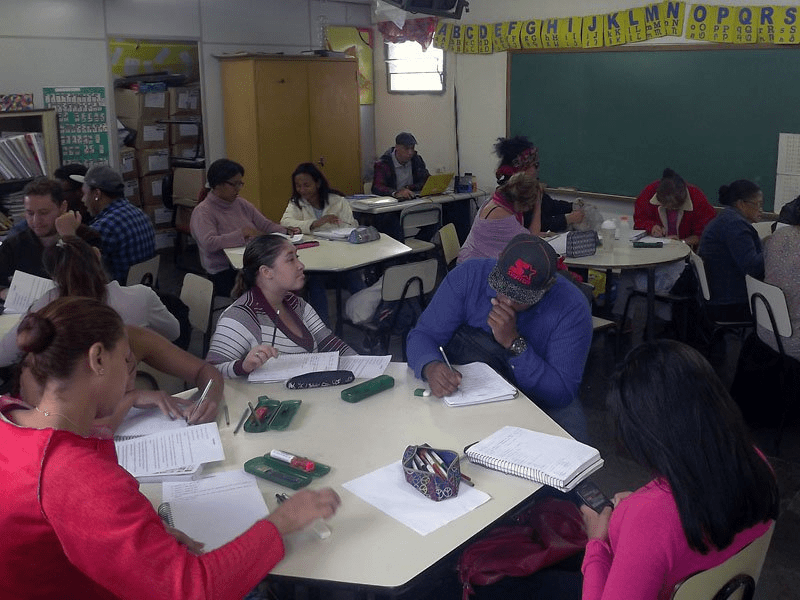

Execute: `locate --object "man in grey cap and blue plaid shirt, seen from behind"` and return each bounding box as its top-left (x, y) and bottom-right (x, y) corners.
top-left (58, 165), bottom-right (156, 285)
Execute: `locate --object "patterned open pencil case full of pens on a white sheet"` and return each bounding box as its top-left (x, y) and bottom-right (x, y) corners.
top-left (401, 444), bottom-right (461, 502)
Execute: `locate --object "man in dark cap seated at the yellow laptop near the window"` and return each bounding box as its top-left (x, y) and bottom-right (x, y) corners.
top-left (372, 132), bottom-right (429, 200)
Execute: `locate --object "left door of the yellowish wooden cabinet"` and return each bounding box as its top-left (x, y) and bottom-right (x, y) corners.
top-left (255, 59), bottom-right (311, 223)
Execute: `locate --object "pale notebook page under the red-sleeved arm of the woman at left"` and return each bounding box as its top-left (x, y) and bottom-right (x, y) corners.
top-left (162, 471), bottom-right (269, 552)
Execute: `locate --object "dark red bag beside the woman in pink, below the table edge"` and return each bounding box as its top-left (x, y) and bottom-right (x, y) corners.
top-left (458, 497), bottom-right (587, 600)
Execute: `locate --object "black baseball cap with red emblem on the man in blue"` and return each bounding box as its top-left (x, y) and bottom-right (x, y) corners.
top-left (489, 233), bottom-right (558, 304)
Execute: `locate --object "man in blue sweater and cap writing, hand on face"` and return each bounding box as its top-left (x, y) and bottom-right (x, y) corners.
top-left (408, 234), bottom-right (592, 440)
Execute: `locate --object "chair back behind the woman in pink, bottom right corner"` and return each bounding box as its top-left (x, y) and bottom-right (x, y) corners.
top-left (672, 523), bottom-right (775, 600)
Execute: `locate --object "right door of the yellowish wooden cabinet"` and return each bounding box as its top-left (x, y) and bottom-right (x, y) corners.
top-left (308, 60), bottom-right (363, 194)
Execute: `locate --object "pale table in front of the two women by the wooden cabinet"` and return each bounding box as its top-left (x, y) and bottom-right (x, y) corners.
top-left (225, 233), bottom-right (411, 336)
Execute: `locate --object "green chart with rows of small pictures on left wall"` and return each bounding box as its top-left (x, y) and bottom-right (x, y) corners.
top-left (42, 87), bottom-right (109, 166)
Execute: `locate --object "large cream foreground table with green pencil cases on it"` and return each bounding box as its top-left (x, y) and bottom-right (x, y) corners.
top-left (141, 363), bottom-right (568, 594)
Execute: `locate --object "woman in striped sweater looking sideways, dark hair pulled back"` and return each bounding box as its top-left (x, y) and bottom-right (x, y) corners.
top-left (206, 235), bottom-right (356, 377)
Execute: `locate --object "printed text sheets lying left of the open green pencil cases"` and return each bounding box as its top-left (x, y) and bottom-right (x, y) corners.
top-left (114, 423), bottom-right (225, 482)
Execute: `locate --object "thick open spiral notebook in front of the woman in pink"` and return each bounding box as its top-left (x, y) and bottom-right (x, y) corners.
top-left (466, 425), bottom-right (603, 492)
